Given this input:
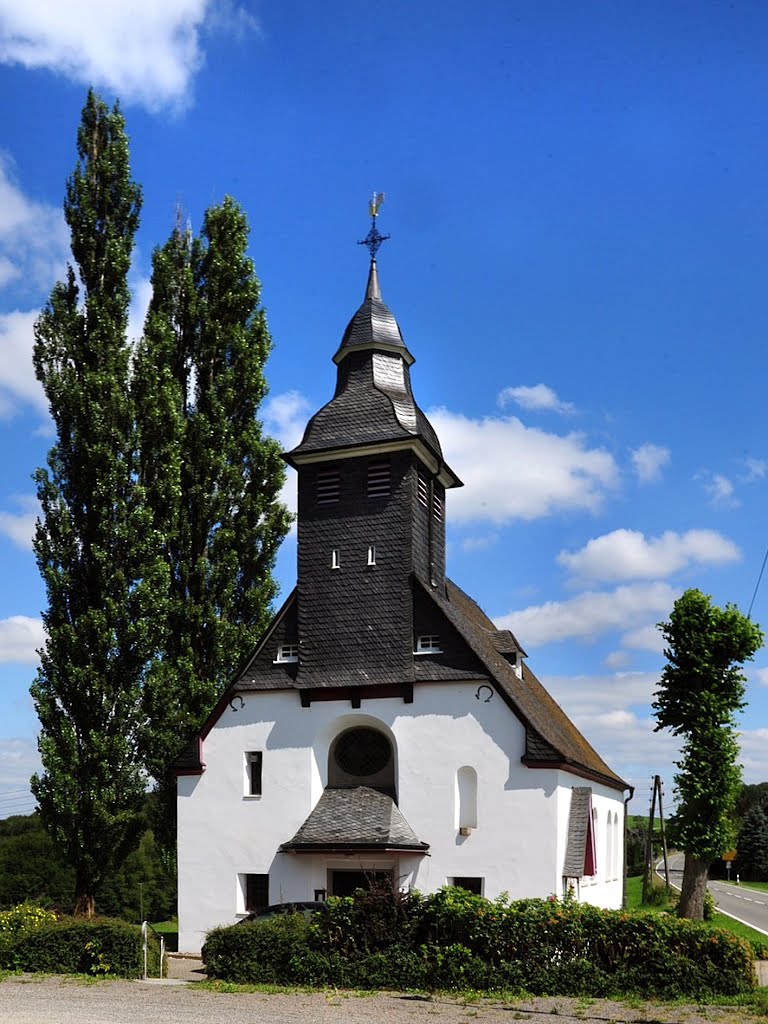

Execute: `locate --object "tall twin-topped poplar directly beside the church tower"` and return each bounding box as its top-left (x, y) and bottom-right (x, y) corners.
top-left (133, 198), bottom-right (290, 841)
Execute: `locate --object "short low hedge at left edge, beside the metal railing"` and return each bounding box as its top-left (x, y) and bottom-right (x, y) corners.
top-left (0, 919), bottom-right (160, 978)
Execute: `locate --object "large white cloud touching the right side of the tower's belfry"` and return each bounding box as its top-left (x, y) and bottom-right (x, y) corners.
top-left (429, 409), bottom-right (618, 525)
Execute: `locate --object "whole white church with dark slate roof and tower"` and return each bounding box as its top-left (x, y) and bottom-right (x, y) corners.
top-left (176, 206), bottom-right (629, 952)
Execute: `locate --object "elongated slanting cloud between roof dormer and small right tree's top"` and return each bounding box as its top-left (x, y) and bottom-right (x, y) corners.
top-left (495, 583), bottom-right (679, 647)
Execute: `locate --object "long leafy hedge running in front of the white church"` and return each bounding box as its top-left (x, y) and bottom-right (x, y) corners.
top-left (205, 888), bottom-right (755, 998)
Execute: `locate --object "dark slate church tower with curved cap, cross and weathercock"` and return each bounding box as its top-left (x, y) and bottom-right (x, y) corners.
top-left (285, 198), bottom-right (461, 688)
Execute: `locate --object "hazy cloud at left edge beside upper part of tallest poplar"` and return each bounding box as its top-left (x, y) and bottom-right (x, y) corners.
top-left (0, 156), bottom-right (69, 291)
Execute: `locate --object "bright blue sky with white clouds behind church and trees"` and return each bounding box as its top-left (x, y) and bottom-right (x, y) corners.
top-left (0, 0), bottom-right (768, 816)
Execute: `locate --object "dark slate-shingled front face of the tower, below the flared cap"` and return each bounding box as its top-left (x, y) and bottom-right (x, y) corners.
top-left (297, 452), bottom-right (415, 686)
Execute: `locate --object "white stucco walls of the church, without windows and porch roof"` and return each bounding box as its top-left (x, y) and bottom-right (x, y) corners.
top-left (178, 683), bottom-right (623, 951)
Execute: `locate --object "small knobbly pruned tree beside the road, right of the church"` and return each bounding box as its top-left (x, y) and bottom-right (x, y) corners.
top-left (653, 590), bottom-right (763, 920)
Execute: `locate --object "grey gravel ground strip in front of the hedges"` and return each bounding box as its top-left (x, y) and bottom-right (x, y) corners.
top-left (0, 976), bottom-right (765, 1024)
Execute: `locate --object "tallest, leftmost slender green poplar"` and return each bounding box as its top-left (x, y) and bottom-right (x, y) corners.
top-left (32, 92), bottom-right (168, 915)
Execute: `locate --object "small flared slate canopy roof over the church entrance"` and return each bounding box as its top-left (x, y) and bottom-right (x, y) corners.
top-left (281, 785), bottom-right (429, 853)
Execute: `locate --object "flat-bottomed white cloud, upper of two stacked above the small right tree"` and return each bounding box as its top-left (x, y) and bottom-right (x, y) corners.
top-left (557, 529), bottom-right (741, 582)
